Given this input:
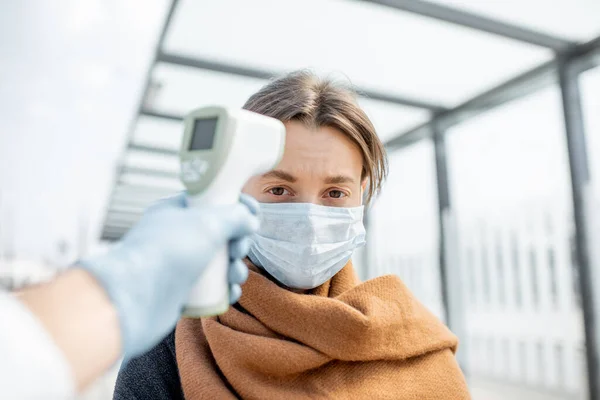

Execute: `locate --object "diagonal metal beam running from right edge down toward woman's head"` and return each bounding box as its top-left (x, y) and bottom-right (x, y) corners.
top-left (385, 37), bottom-right (600, 150)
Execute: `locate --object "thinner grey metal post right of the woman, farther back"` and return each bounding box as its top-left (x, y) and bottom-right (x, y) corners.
top-left (432, 121), bottom-right (469, 375)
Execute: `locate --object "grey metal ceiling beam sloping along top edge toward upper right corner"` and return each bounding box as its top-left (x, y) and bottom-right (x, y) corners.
top-left (361, 0), bottom-right (575, 52)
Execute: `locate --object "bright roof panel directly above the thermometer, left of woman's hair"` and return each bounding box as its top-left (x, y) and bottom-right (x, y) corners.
top-left (151, 63), bottom-right (266, 115)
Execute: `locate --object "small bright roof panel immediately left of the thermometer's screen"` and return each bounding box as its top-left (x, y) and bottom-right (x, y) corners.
top-left (131, 115), bottom-right (183, 151)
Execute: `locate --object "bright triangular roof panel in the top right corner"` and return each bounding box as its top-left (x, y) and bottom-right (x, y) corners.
top-left (426, 0), bottom-right (600, 41)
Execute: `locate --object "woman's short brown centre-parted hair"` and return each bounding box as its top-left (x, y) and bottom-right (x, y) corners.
top-left (244, 70), bottom-right (387, 203)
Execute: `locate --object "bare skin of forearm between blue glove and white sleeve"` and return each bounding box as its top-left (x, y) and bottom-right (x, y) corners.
top-left (19, 269), bottom-right (121, 390)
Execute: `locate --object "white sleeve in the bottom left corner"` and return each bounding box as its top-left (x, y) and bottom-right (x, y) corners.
top-left (0, 291), bottom-right (75, 400)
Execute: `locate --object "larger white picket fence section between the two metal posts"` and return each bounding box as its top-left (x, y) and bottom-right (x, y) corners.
top-left (459, 199), bottom-right (585, 393)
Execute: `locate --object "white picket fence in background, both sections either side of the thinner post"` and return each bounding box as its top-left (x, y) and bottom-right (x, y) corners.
top-left (366, 198), bottom-right (586, 398)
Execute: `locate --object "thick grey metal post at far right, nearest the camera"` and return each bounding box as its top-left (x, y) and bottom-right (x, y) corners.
top-left (558, 58), bottom-right (600, 400)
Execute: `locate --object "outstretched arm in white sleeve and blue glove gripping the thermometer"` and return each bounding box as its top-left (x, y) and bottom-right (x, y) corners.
top-left (0, 195), bottom-right (258, 399)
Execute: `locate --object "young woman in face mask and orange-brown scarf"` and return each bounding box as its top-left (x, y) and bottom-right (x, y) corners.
top-left (115, 71), bottom-right (470, 400)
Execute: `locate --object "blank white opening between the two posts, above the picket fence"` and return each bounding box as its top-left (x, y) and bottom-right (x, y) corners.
top-left (448, 86), bottom-right (570, 215)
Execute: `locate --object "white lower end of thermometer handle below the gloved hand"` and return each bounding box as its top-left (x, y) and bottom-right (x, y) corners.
top-left (183, 246), bottom-right (229, 318)
